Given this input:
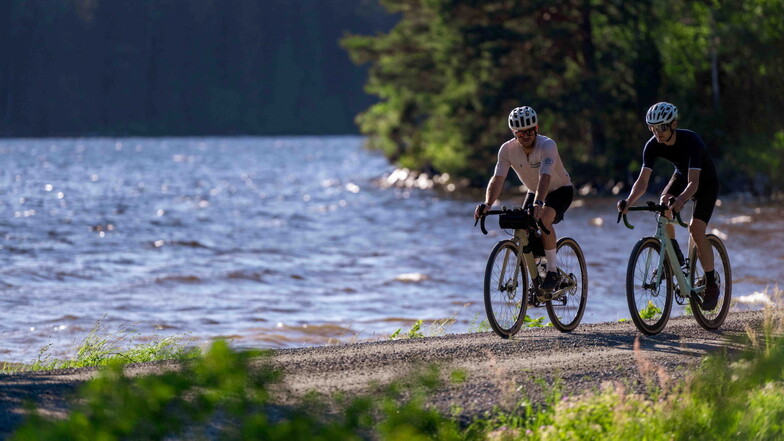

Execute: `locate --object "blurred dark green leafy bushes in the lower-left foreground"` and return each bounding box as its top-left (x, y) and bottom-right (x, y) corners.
top-left (12, 341), bottom-right (464, 441)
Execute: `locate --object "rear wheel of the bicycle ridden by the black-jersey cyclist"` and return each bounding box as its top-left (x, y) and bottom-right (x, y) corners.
top-left (689, 234), bottom-right (732, 331)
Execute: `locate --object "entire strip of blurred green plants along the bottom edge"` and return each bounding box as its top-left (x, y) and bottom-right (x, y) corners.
top-left (13, 312), bottom-right (784, 440)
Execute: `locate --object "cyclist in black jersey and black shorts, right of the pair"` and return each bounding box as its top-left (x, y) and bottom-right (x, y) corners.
top-left (618, 102), bottom-right (719, 310)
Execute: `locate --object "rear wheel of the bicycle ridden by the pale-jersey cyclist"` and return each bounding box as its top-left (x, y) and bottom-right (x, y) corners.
top-left (546, 237), bottom-right (588, 332)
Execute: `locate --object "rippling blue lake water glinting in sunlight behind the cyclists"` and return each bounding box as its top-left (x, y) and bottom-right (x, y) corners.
top-left (0, 137), bottom-right (784, 362)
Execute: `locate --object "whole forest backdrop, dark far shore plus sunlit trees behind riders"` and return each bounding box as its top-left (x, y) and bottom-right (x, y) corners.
top-left (0, 0), bottom-right (784, 194)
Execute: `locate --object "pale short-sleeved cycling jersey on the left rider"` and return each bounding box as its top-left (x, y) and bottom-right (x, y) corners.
top-left (494, 135), bottom-right (572, 193)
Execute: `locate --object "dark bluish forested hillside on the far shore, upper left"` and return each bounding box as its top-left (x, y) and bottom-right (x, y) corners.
top-left (0, 0), bottom-right (398, 137)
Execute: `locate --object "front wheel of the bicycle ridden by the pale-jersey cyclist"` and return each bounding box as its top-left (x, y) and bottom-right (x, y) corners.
top-left (485, 240), bottom-right (528, 338)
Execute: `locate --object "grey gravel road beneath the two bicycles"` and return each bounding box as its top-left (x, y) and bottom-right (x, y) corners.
top-left (0, 311), bottom-right (763, 439)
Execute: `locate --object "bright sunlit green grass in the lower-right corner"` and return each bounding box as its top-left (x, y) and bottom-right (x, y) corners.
top-left (475, 306), bottom-right (784, 440)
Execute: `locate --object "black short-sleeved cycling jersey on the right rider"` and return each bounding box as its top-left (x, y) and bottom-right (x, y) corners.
top-left (642, 129), bottom-right (719, 193)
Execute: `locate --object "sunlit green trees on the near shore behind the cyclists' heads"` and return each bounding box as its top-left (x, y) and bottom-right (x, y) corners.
top-left (343, 0), bottom-right (784, 195)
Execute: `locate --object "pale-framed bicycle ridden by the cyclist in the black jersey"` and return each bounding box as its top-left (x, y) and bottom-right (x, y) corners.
top-left (618, 201), bottom-right (732, 335)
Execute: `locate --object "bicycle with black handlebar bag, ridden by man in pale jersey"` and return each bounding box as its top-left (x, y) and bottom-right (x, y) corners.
top-left (474, 207), bottom-right (588, 338)
